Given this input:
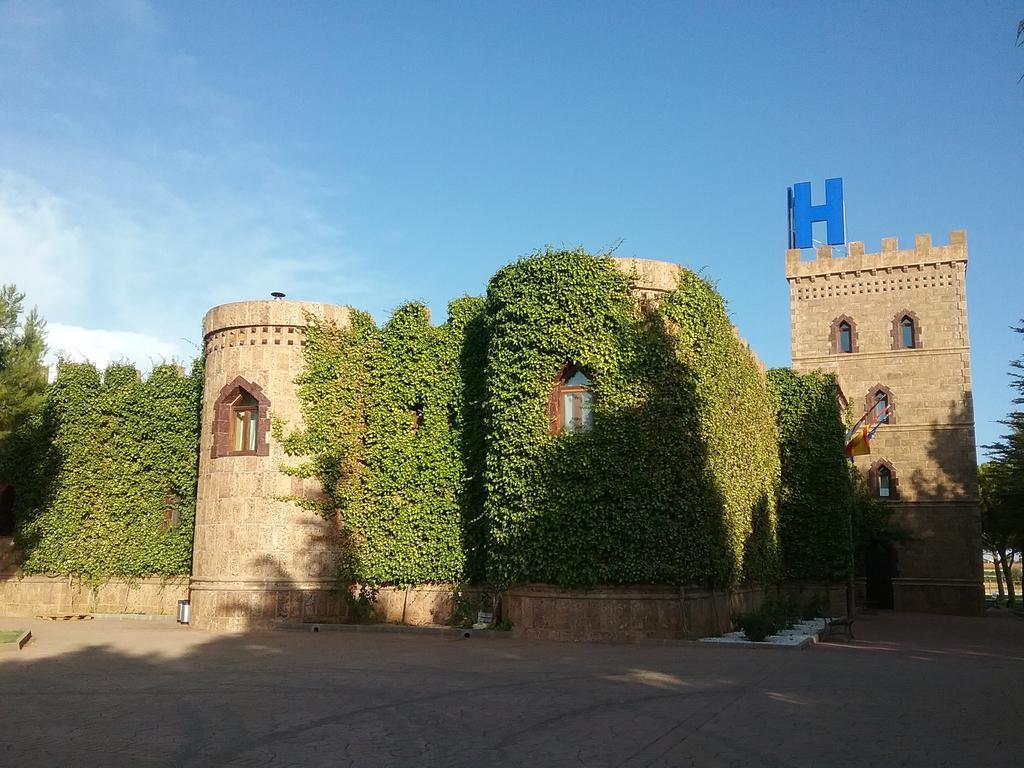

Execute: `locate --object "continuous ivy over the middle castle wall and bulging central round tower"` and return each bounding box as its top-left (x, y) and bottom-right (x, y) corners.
top-left (288, 250), bottom-right (779, 586)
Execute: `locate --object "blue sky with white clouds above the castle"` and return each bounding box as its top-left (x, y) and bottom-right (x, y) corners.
top-left (0, 0), bottom-right (1024, 454)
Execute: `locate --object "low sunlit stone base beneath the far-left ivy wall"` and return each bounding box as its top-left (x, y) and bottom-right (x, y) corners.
top-left (0, 574), bottom-right (188, 616)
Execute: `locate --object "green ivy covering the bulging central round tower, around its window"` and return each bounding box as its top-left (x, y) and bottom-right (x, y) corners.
top-left (484, 250), bottom-right (779, 586)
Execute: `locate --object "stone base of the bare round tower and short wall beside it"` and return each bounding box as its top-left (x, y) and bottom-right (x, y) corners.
top-left (190, 580), bottom-right (455, 632)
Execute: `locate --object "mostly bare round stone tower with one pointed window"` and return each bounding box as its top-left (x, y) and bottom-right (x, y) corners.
top-left (190, 300), bottom-right (349, 630)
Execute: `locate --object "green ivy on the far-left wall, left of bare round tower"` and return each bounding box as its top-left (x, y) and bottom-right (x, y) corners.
top-left (0, 361), bottom-right (203, 581)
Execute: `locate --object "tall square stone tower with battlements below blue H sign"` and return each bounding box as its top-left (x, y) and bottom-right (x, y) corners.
top-left (785, 230), bottom-right (984, 615)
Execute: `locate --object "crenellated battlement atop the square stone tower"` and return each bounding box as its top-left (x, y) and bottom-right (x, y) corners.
top-left (785, 229), bottom-right (967, 280)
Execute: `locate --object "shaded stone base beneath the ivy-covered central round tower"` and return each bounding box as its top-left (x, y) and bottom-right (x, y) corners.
top-left (502, 584), bottom-right (846, 642)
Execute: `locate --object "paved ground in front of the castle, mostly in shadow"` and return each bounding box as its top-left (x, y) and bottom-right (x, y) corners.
top-left (0, 613), bottom-right (1024, 768)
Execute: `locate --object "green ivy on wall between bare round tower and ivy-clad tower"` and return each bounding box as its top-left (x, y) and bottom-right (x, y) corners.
top-left (275, 298), bottom-right (483, 585)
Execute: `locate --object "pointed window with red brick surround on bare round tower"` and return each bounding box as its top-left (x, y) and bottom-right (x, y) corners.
top-left (210, 376), bottom-right (270, 459)
